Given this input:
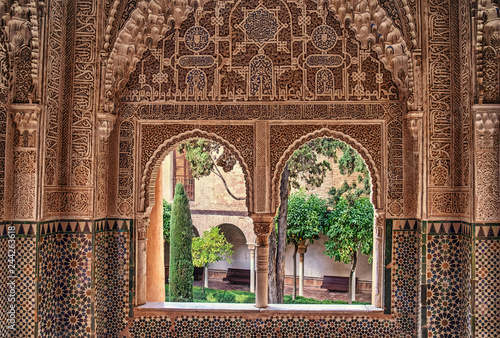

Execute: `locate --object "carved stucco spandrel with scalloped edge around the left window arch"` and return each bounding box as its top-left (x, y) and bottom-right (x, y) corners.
top-left (138, 125), bottom-right (253, 215)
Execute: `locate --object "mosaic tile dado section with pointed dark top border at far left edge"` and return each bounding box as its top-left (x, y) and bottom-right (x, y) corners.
top-left (0, 222), bottom-right (36, 338)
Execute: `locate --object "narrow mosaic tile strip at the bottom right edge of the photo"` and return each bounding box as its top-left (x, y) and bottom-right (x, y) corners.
top-left (475, 240), bottom-right (500, 338)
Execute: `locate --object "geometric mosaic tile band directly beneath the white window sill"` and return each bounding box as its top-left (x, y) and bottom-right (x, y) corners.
top-left (130, 316), bottom-right (398, 338)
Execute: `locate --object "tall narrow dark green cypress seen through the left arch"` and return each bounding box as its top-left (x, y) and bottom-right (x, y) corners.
top-left (169, 183), bottom-right (194, 302)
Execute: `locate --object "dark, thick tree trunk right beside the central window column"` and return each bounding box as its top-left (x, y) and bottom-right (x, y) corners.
top-left (276, 163), bottom-right (290, 304)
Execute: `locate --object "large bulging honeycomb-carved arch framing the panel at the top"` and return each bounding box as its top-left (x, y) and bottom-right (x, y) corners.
top-left (104, 0), bottom-right (413, 112)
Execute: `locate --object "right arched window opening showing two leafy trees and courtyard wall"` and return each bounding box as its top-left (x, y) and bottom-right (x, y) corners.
top-left (269, 138), bottom-right (374, 304)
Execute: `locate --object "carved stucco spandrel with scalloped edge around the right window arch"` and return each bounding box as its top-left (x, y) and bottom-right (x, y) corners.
top-left (271, 124), bottom-right (384, 210)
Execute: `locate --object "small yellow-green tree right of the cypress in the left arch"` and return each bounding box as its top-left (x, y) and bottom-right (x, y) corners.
top-left (192, 227), bottom-right (233, 292)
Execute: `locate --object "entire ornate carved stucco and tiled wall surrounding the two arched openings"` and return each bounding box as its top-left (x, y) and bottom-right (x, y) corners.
top-left (0, 0), bottom-right (500, 337)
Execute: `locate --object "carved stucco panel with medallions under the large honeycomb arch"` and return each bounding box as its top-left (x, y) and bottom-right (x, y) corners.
top-left (115, 0), bottom-right (400, 102)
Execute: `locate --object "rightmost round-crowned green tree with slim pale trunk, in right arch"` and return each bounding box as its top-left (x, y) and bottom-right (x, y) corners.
top-left (324, 196), bottom-right (373, 304)
